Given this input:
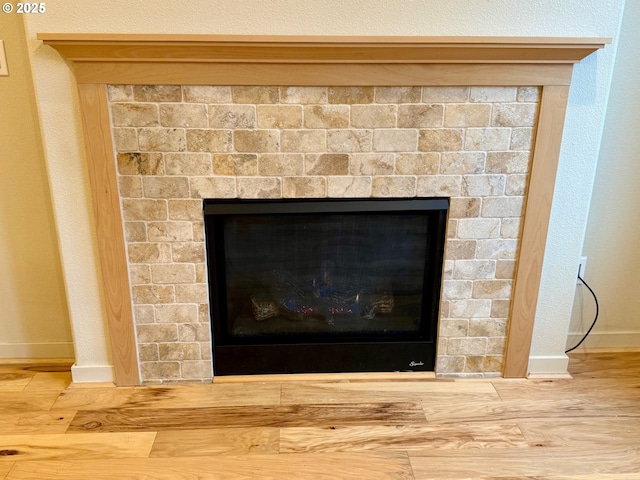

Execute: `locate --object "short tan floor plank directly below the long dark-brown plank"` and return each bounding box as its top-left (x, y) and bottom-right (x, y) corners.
top-left (151, 427), bottom-right (280, 457)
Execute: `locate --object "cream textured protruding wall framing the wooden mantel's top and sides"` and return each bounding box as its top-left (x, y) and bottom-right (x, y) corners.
top-left (26, 0), bottom-right (624, 380)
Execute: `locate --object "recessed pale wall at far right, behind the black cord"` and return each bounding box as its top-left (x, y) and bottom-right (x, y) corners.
top-left (569, 1), bottom-right (640, 348)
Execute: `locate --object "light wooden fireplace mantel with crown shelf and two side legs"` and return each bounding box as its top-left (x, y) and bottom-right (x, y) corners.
top-left (38, 33), bottom-right (611, 385)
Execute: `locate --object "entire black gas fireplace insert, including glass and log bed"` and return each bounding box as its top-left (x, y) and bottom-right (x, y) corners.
top-left (204, 198), bottom-right (449, 375)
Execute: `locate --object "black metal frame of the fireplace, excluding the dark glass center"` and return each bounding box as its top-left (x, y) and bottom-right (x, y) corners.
top-left (204, 197), bottom-right (449, 375)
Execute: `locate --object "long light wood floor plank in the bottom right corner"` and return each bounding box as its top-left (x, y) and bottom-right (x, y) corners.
top-left (409, 446), bottom-right (640, 480)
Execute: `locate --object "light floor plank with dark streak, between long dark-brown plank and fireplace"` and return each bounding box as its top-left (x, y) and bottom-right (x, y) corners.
top-left (53, 384), bottom-right (280, 410)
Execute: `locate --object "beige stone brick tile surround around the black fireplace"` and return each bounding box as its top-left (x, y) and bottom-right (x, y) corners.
top-left (108, 85), bottom-right (539, 384)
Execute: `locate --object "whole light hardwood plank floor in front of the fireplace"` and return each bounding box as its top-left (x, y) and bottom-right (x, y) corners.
top-left (0, 352), bottom-right (640, 480)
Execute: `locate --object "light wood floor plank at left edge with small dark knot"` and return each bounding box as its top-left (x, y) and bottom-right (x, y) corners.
top-left (0, 432), bottom-right (156, 462)
